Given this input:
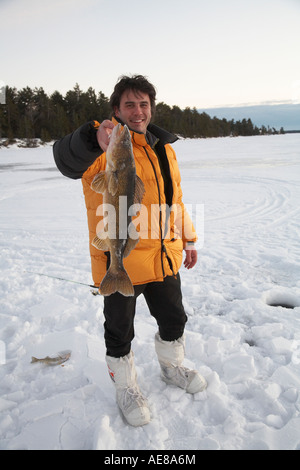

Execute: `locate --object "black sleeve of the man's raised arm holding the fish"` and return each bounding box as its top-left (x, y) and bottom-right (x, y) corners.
top-left (53, 121), bottom-right (103, 179)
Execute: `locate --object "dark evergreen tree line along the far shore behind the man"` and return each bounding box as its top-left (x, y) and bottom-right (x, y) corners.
top-left (0, 84), bottom-right (284, 143)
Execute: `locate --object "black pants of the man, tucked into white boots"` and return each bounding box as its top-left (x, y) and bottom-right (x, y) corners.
top-left (104, 274), bottom-right (187, 357)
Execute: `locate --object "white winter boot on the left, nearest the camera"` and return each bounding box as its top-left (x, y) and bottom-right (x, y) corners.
top-left (106, 351), bottom-right (150, 426)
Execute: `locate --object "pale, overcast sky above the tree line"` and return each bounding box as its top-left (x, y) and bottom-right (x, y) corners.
top-left (0, 0), bottom-right (300, 108)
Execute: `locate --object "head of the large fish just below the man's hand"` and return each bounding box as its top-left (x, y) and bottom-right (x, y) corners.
top-left (106, 123), bottom-right (133, 161)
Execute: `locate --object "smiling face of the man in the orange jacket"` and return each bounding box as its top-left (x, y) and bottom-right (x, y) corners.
top-left (114, 90), bottom-right (151, 134)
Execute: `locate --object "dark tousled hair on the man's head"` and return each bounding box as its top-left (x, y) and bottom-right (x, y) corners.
top-left (109, 75), bottom-right (156, 116)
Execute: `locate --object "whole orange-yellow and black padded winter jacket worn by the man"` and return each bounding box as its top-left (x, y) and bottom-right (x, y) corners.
top-left (53, 119), bottom-right (197, 286)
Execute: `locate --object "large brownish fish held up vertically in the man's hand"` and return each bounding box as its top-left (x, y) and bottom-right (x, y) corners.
top-left (91, 123), bottom-right (145, 297)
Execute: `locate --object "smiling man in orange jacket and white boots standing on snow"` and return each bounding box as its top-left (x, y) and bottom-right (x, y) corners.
top-left (53, 75), bottom-right (206, 426)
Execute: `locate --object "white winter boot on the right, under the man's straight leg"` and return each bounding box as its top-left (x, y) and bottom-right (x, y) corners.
top-left (155, 333), bottom-right (207, 393)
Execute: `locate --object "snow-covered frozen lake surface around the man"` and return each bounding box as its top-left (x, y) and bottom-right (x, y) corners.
top-left (0, 134), bottom-right (300, 450)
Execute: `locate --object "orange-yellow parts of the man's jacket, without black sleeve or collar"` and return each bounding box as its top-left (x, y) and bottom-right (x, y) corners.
top-left (82, 119), bottom-right (197, 286)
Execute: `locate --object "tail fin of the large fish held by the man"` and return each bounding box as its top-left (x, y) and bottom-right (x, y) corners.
top-left (100, 268), bottom-right (134, 297)
